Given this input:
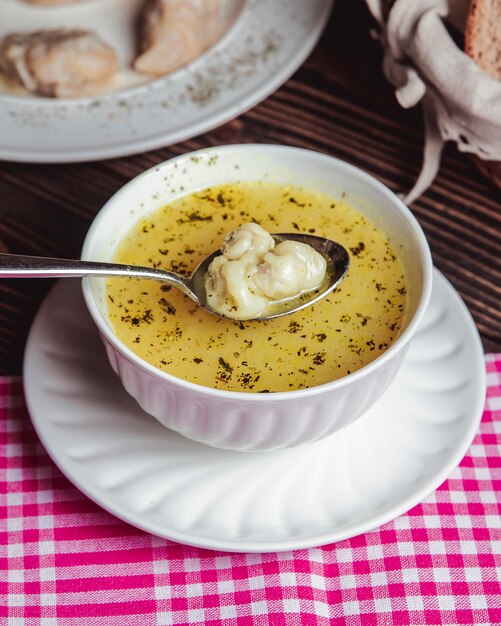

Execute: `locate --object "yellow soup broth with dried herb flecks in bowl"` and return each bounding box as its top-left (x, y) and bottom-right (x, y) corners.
top-left (107, 183), bottom-right (406, 393)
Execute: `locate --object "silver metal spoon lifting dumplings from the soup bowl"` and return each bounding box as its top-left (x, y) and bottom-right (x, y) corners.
top-left (0, 233), bottom-right (350, 321)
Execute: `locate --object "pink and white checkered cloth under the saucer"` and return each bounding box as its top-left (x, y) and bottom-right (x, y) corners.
top-left (0, 354), bottom-right (501, 626)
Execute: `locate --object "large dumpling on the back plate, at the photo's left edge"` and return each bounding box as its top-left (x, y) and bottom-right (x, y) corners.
top-left (0, 29), bottom-right (117, 98)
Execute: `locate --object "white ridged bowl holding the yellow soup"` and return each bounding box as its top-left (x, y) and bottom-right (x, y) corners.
top-left (82, 144), bottom-right (432, 450)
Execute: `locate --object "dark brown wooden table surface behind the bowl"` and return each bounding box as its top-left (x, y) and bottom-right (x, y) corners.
top-left (0, 0), bottom-right (501, 375)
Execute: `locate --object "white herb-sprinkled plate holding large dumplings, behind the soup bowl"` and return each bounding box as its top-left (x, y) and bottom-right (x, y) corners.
top-left (0, 0), bottom-right (332, 163)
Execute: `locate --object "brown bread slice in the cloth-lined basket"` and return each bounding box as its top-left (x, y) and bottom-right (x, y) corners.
top-left (465, 0), bottom-right (501, 80)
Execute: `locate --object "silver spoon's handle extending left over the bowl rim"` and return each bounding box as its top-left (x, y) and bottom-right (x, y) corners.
top-left (0, 253), bottom-right (196, 298)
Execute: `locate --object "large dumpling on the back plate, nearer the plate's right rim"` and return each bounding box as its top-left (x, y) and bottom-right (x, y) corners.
top-left (133, 0), bottom-right (224, 76)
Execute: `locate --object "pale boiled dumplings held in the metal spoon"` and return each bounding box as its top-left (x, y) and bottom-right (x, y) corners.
top-left (206, 222), bottom-right (327, 319)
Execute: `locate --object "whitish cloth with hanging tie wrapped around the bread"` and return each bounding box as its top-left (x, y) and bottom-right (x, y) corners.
top-left (366, 0), bottom-right (501, 203)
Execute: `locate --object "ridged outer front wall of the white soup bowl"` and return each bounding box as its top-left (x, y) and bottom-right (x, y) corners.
top-left (102, 336), bottom-right (407, 451)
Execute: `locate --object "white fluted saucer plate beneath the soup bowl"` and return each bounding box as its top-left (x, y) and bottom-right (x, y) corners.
top-left (24, 272), bottom-right (485, 552)
